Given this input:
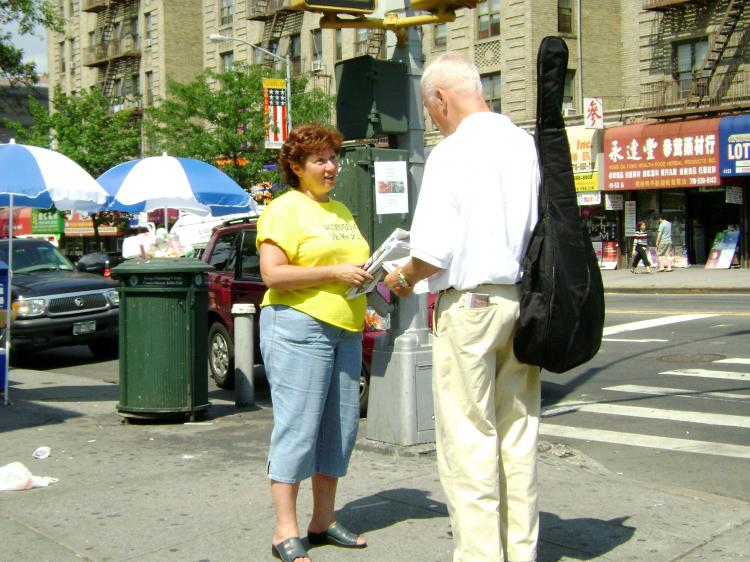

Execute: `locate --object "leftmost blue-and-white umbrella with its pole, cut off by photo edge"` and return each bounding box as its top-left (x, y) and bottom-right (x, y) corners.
top-left (0, 139), bottom-right (107, 404)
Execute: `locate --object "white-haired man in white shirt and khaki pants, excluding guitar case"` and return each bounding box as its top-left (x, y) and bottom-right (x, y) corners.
top-left (385, 53), bottom-right (540, 562)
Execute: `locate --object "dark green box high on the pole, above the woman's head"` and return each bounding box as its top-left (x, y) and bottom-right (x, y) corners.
top-left (334, 55), bottom-right (409, 140)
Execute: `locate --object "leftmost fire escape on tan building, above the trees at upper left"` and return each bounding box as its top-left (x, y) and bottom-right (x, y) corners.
top-left (81, 0), bottom-right (141, 110)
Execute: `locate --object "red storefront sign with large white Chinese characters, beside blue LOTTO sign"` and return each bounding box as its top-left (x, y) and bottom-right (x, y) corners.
top-left (604, 118), bottom-right (721, 191)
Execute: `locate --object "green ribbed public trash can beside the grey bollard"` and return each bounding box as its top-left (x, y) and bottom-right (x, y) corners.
top-left (112, 258), bottom-right (212, 420)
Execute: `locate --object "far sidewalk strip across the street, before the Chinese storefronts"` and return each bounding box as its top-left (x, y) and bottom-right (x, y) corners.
top-left (602, 266), bottom-right (750, 294)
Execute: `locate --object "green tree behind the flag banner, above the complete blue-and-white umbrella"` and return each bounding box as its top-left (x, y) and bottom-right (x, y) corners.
top-left (145, 63), bottom-right (334, 189)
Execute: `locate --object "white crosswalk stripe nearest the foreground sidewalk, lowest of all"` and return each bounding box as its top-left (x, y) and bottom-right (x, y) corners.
top-left (539, 423), bottom-right (750, 459)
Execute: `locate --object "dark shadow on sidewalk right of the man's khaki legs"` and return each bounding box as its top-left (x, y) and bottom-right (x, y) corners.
top-left (539, 511), bottom-right (635, 562)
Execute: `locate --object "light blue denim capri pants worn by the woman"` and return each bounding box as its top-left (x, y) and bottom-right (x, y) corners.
top-left (260, 305), bottom-right (362, 484)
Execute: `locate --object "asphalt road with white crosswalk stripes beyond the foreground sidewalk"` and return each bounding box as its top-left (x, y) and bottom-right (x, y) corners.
top-left (16, 295), bottom-right (750, 501)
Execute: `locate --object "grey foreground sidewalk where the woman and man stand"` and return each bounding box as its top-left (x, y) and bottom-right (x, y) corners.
top-left (0, 368), bottom-right (750, 562)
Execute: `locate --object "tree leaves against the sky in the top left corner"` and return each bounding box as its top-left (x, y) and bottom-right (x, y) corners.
top-left (0, 0), bottom-right (63, 85)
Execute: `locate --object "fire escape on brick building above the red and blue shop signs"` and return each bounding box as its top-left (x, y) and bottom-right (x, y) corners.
top-left (643, 0), bottom-right (750, 118)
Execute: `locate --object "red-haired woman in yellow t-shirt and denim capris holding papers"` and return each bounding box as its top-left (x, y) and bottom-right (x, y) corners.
top-left (256, 125), bottom-right (372, 562)
